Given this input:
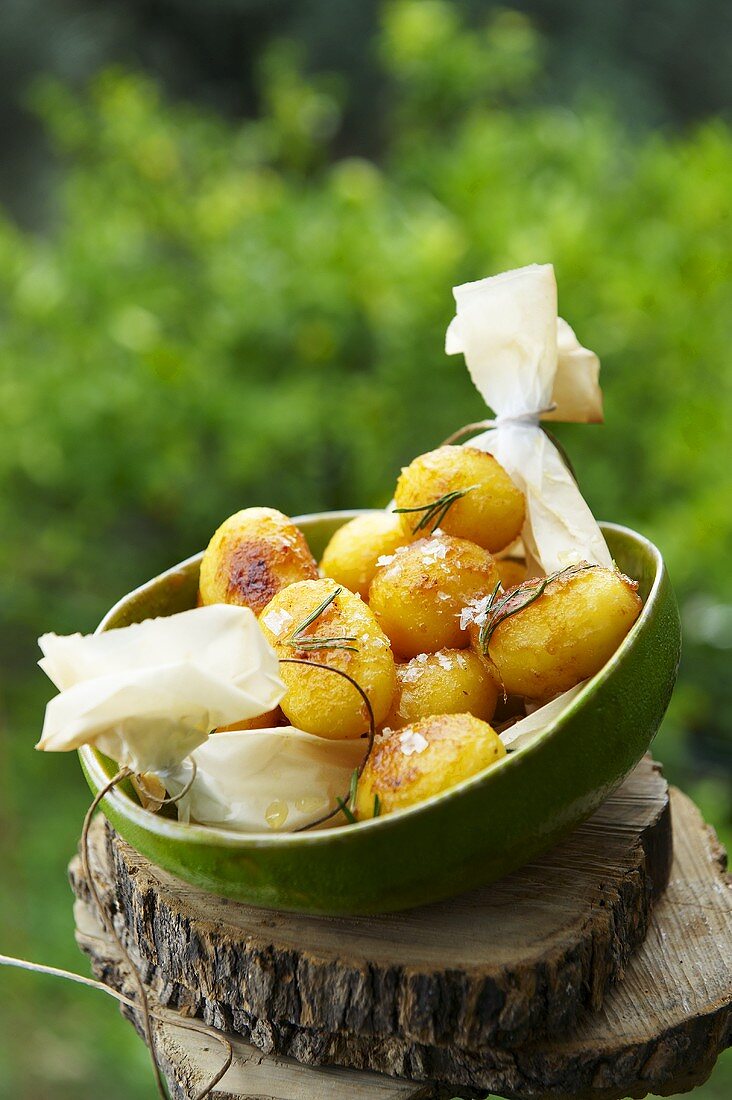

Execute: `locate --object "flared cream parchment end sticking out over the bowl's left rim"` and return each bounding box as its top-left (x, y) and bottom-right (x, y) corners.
top-left (36, 604), bottom-right (284, 776)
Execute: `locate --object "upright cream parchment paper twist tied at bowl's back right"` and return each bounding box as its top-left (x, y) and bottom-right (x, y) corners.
top-left (445, 264), bottom-right (612, 573)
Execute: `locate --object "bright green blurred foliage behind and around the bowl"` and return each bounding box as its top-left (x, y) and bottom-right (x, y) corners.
top-left (0, 0), bottom-right (732, 1100)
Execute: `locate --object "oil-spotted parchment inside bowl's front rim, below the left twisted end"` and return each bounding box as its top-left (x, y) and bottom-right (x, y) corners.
top-left (167, 726), bottom-right (367, 833)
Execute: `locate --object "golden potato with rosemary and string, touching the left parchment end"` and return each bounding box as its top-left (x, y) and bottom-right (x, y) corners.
top-left (260, 579), bottom-right (396, 739)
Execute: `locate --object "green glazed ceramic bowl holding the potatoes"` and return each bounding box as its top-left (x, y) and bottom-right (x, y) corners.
top-left (79, 512), bottom-right (680, 914)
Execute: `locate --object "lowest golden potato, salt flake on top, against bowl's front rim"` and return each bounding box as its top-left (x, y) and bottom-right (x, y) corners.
top-left (356, 714), bottom-right (505, 817)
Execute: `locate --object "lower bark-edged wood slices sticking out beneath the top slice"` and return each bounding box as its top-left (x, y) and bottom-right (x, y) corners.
top-left (73, 778), bottom-right (732, 1100)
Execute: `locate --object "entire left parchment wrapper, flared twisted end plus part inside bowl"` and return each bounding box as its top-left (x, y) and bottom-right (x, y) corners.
top-left (36, 604), bottom-right (365, 832)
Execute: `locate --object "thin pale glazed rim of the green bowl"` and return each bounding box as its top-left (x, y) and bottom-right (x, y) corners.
top-left (78, 508), bottom-right (665, 849)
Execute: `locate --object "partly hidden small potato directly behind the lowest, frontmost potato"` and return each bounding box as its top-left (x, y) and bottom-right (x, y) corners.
top-left (385, 649), bottom-right (499, 729)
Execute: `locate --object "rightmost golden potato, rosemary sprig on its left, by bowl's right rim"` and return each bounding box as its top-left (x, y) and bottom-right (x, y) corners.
top-left (482, 567), bottom-right (643, 702)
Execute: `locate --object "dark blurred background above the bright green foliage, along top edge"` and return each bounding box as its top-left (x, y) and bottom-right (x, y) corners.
top-left (0, 0), bottom-right (732, 224)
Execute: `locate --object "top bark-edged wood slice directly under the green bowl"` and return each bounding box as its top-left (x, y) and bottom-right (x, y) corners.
top-left (73, 759), bottom-right (671, 1060)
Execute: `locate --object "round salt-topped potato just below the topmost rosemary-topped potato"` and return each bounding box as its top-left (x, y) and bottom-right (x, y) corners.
top-left (369, 535), bottom-right (499, 658)
